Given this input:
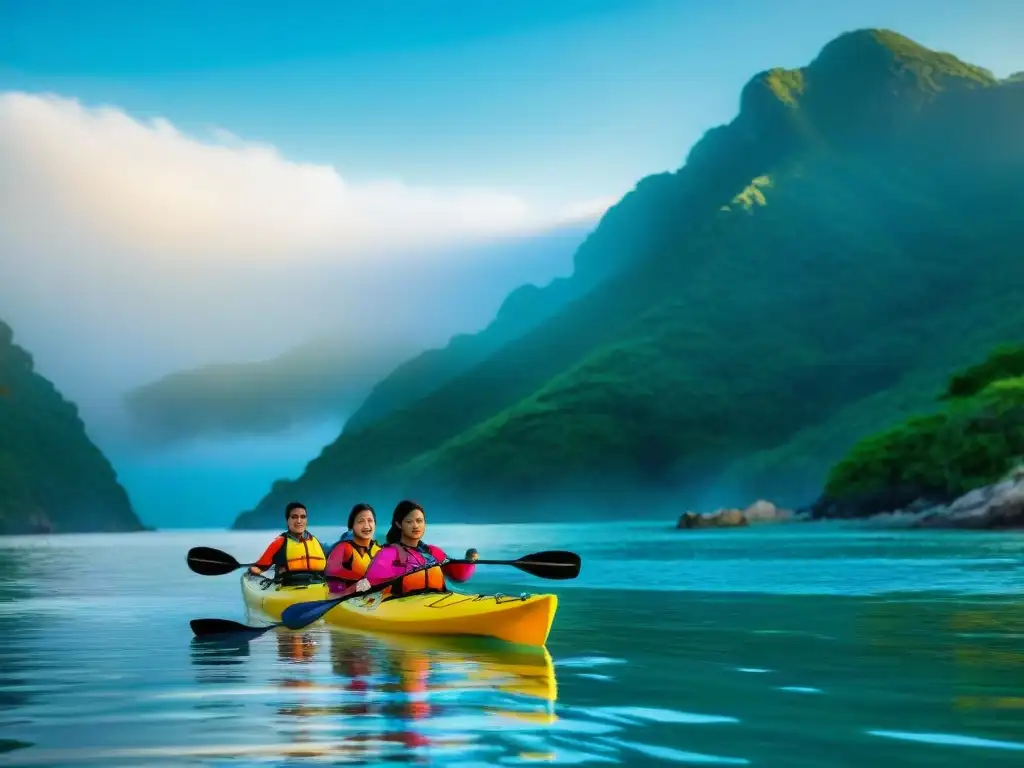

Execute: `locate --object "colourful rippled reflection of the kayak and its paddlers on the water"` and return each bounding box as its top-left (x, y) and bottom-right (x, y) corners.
top-left (260, 628), bottom-right (557, 762)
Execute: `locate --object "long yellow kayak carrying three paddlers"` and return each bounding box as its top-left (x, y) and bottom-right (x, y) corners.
top-left (242, 572), bottom-right (558, 645)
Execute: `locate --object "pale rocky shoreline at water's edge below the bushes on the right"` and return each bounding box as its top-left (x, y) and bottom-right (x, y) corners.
top-left (676, 465), bottom-right (1024, 530)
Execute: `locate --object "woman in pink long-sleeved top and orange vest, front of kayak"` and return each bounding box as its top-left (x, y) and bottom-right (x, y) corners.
top-left (356, 501), bottom-right (477, 599)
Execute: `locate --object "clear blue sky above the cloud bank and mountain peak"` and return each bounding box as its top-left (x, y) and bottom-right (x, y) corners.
top-left (6, 0), bottom-right (1024, 210)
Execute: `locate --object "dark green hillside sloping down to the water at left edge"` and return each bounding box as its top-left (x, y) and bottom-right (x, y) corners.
top-left (0, 322), bottom-right (142, 535)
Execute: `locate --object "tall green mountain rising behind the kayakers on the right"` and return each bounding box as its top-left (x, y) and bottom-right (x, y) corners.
top-left (236, 30), bottom-right (1024, 527)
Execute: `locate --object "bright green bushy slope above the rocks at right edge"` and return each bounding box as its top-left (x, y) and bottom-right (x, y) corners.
top-left (815, 346), bottom-right (1024, 516)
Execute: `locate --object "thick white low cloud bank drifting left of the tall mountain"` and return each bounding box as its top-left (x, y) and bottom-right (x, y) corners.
top-left (0, 92), bottom-right (612, 438)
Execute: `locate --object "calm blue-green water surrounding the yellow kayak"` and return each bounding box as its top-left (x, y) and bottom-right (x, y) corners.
top-left (0, 524), bottom-right (1024, 768)
